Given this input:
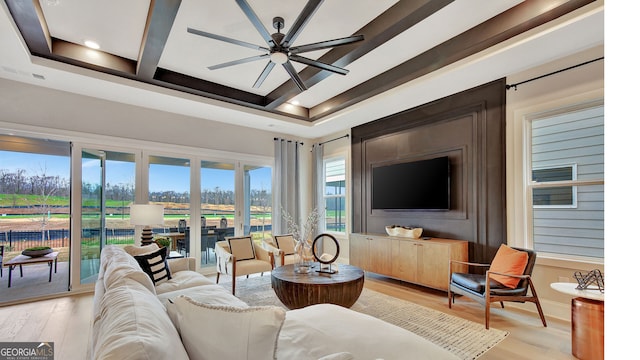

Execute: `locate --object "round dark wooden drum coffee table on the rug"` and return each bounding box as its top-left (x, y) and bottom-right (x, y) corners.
top-left (271, 264), bottom-right (364, 309)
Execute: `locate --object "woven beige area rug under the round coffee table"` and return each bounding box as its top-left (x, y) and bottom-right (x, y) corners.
top-left (220, 273), bottom-right (509, 360)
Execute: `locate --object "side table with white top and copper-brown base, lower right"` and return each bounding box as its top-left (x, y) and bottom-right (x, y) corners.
top-left (551, 283), bottom-right (604, 360)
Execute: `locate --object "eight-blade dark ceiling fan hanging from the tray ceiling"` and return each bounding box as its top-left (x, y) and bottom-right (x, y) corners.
top-left (187, 0), bottom-right (364, 91)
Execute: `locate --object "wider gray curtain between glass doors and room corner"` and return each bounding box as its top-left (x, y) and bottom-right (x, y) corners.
top-left (271, 138), bottom-right (302, 235)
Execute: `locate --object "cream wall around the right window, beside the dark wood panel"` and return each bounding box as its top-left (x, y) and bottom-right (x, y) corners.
top-left (506, 46), bottom-right (606, 320)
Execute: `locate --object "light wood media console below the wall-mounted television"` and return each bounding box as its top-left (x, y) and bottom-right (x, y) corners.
top-left (349, 233), bottom-right (469, 291)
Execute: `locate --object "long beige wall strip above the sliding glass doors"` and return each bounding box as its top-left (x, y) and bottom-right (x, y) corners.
top-left (0, 79), bottom-right (304, 157)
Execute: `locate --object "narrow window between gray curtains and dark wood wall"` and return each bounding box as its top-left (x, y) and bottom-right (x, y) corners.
top-left (323, 157), bottom-right (346, 233)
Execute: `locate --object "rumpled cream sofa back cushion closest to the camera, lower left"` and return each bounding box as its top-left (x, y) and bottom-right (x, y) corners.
top-left (92, 275), bottom-right (189, 360)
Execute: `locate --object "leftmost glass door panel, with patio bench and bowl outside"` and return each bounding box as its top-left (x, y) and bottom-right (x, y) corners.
top-left (0, 135), bottom-right (71, 303)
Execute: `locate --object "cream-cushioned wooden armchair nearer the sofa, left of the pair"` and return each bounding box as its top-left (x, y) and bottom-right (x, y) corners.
top-left (215, 236), bottom-right (273, 295)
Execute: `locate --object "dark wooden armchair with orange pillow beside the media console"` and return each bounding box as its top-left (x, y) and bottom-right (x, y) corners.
top-left (448, 245), bottom-right (547, 329)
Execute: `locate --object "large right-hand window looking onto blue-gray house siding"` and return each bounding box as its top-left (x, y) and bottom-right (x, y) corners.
top-left (527, 104), bottom-right (604, 259)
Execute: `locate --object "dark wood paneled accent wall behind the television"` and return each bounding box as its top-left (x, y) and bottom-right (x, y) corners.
top-left (351, 79), bottom-right (506, 263)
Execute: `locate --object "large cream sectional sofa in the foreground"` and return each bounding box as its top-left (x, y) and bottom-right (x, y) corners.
top-left (92, 244), bottom-right (457, 360)
